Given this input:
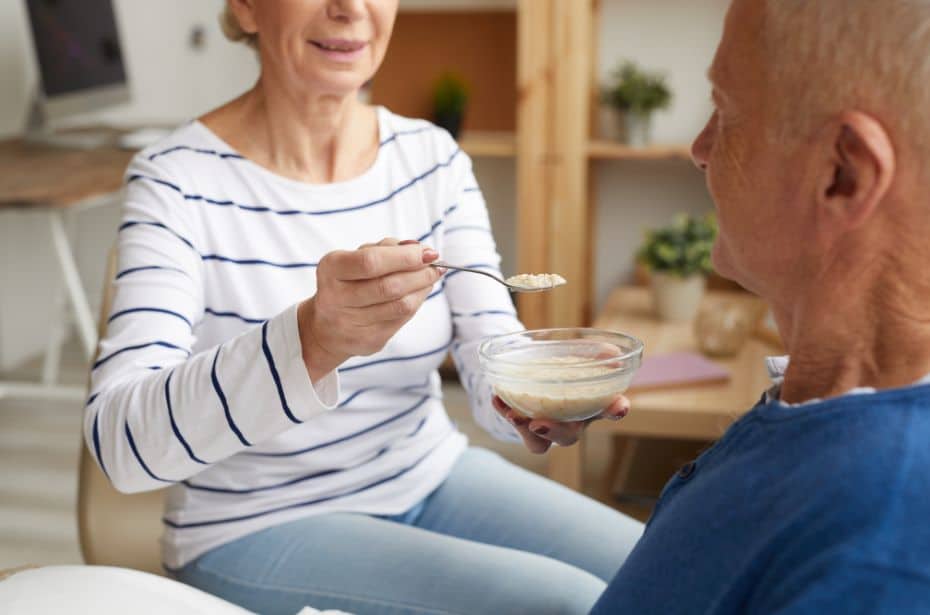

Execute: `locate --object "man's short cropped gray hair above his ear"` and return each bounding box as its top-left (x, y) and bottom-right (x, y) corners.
top-left (750, 0), bottom-right (930, 151)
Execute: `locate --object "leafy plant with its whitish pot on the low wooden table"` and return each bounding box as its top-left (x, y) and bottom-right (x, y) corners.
top-left (638, 214), bottom-right (717, 321)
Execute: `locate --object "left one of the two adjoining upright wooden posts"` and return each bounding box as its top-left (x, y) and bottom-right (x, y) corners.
top-left (517, 0), bottom-right (553, 329)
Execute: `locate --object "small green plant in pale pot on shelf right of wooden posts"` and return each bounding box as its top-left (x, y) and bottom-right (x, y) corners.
top-left (601, 61), bottom-right (672, 147)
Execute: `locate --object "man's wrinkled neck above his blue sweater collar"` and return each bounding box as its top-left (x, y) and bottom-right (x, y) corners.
top-left (775, 269), bottom-right (930, 403)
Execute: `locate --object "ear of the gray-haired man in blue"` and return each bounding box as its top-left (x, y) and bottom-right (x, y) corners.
top-left (817, 111), bottom-right (896, 232)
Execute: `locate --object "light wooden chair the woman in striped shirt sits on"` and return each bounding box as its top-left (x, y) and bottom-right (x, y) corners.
top-left (77, 249), bottom-right (165, 575)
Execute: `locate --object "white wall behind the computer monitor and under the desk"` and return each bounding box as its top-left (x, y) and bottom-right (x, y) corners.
top-left (0, 0), bottom-right (258, 369)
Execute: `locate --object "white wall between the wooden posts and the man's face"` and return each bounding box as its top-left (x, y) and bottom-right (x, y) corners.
top-left (594, 0), bottom-right (729, 306)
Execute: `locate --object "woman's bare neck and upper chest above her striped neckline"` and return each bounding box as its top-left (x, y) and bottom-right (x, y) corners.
top-left (201, 74), bottom-right (379, 184)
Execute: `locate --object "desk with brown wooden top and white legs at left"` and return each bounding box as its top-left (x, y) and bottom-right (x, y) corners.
top-left (0, 139), bottom-right (133, 400)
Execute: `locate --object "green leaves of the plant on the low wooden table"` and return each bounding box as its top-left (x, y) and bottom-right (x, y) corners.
top-left (637, 214), bottom-right (717, 277)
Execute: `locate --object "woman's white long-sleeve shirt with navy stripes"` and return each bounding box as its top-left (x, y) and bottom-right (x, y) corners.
top-left (85, 109), bottom-right (521, 569)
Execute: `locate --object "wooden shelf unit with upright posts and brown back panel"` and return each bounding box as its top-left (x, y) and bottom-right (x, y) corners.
top-left (372, 0), bottom-right (690, 336)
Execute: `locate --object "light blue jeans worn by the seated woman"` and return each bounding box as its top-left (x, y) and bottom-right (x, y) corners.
top-left (177, 448), bottom-right (642, 615)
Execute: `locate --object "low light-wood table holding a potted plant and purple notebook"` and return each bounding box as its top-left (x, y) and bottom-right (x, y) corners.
top-left (549, 287), bottom-right (778, 490)
